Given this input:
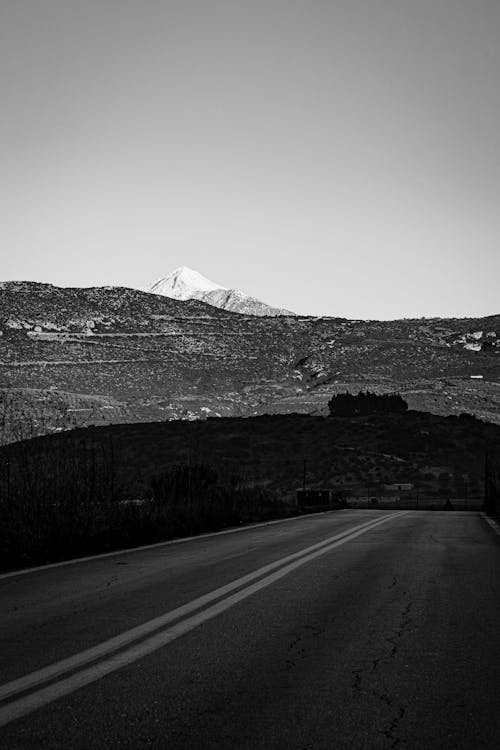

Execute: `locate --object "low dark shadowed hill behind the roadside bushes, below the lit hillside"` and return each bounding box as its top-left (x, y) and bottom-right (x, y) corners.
top-left (0, 411), bottom-right (500, 500)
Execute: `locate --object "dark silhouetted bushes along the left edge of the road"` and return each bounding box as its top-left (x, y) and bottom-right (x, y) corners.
top-left (0, 446), bottom-right (290, 568)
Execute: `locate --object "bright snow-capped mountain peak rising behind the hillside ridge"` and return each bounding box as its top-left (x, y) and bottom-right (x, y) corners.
top-left (146, 266), bottom-right (294, 316)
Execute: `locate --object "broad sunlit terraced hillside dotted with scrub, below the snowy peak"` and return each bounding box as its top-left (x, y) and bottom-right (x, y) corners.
top-left (0, 282), bottom-right (500, 442)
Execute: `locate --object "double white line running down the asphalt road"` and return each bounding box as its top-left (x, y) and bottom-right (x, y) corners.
top-left (0, 512), bottom-right (405, 727)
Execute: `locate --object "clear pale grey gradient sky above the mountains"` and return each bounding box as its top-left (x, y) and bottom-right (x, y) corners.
top-left (0, 0), bottom-right (500, 318)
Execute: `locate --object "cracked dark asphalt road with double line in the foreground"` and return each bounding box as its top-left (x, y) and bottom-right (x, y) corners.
top-left (0, 510), bottom-right (500, 750)
